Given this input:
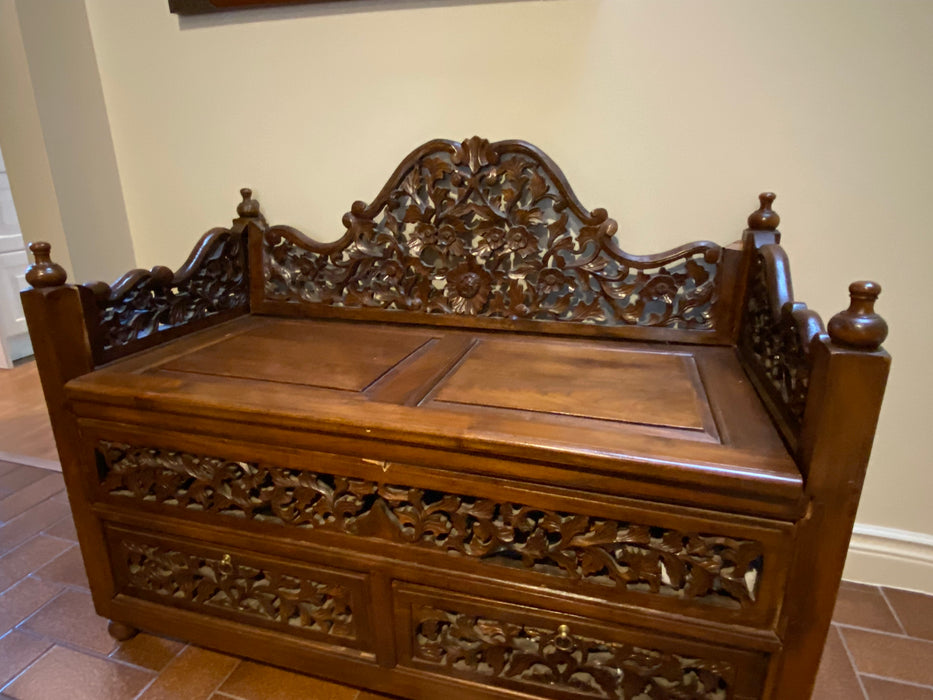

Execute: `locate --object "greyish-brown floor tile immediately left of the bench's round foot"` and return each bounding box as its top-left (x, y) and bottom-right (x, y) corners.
top-left (20, 590), bottom-right (117, 654)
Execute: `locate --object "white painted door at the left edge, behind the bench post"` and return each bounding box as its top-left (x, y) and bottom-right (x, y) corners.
top-left (0, 147), bottom-right (32, 368)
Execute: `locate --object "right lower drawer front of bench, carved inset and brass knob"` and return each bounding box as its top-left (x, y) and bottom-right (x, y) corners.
top-left (395, 583), bottom-right (767, 700)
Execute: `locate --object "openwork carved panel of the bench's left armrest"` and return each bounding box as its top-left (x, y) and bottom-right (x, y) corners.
top-left (88, 229), bottom-right (249, 360)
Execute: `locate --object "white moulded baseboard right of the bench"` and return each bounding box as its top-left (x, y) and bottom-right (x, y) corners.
top-left (842, 523), bottom-right (933, 594)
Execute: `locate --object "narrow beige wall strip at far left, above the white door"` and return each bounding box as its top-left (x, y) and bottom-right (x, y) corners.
top-left (0, 0), bottom-right (74, 278)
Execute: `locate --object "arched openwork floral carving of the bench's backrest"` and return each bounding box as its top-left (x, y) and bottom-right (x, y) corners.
top-left (264, 137), bottom-right (721, 330)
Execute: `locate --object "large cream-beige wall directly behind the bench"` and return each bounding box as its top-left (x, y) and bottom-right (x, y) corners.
top-left (71, 0), bottom-right (933, 580)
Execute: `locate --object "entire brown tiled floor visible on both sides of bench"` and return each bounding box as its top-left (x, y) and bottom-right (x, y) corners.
top-left (0, 462), bottom-right (933, 700)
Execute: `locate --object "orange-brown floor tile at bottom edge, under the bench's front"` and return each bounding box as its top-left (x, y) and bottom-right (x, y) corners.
top-left (219, 661), bottom-right (359, 700)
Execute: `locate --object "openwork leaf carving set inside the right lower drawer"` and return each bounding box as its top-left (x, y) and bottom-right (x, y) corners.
top-left (413, 606), bottom-right (734, 700)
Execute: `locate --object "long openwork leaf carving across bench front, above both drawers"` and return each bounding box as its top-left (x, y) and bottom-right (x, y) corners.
top-left (98, 442), bottom-right (763, 608)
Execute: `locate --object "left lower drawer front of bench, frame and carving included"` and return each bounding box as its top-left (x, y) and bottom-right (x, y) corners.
top-left (107, 525), bottom-right (372, 650)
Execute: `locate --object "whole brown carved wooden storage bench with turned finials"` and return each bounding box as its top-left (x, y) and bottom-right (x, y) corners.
top-left (23, 138), bottom-right (890, 700)
